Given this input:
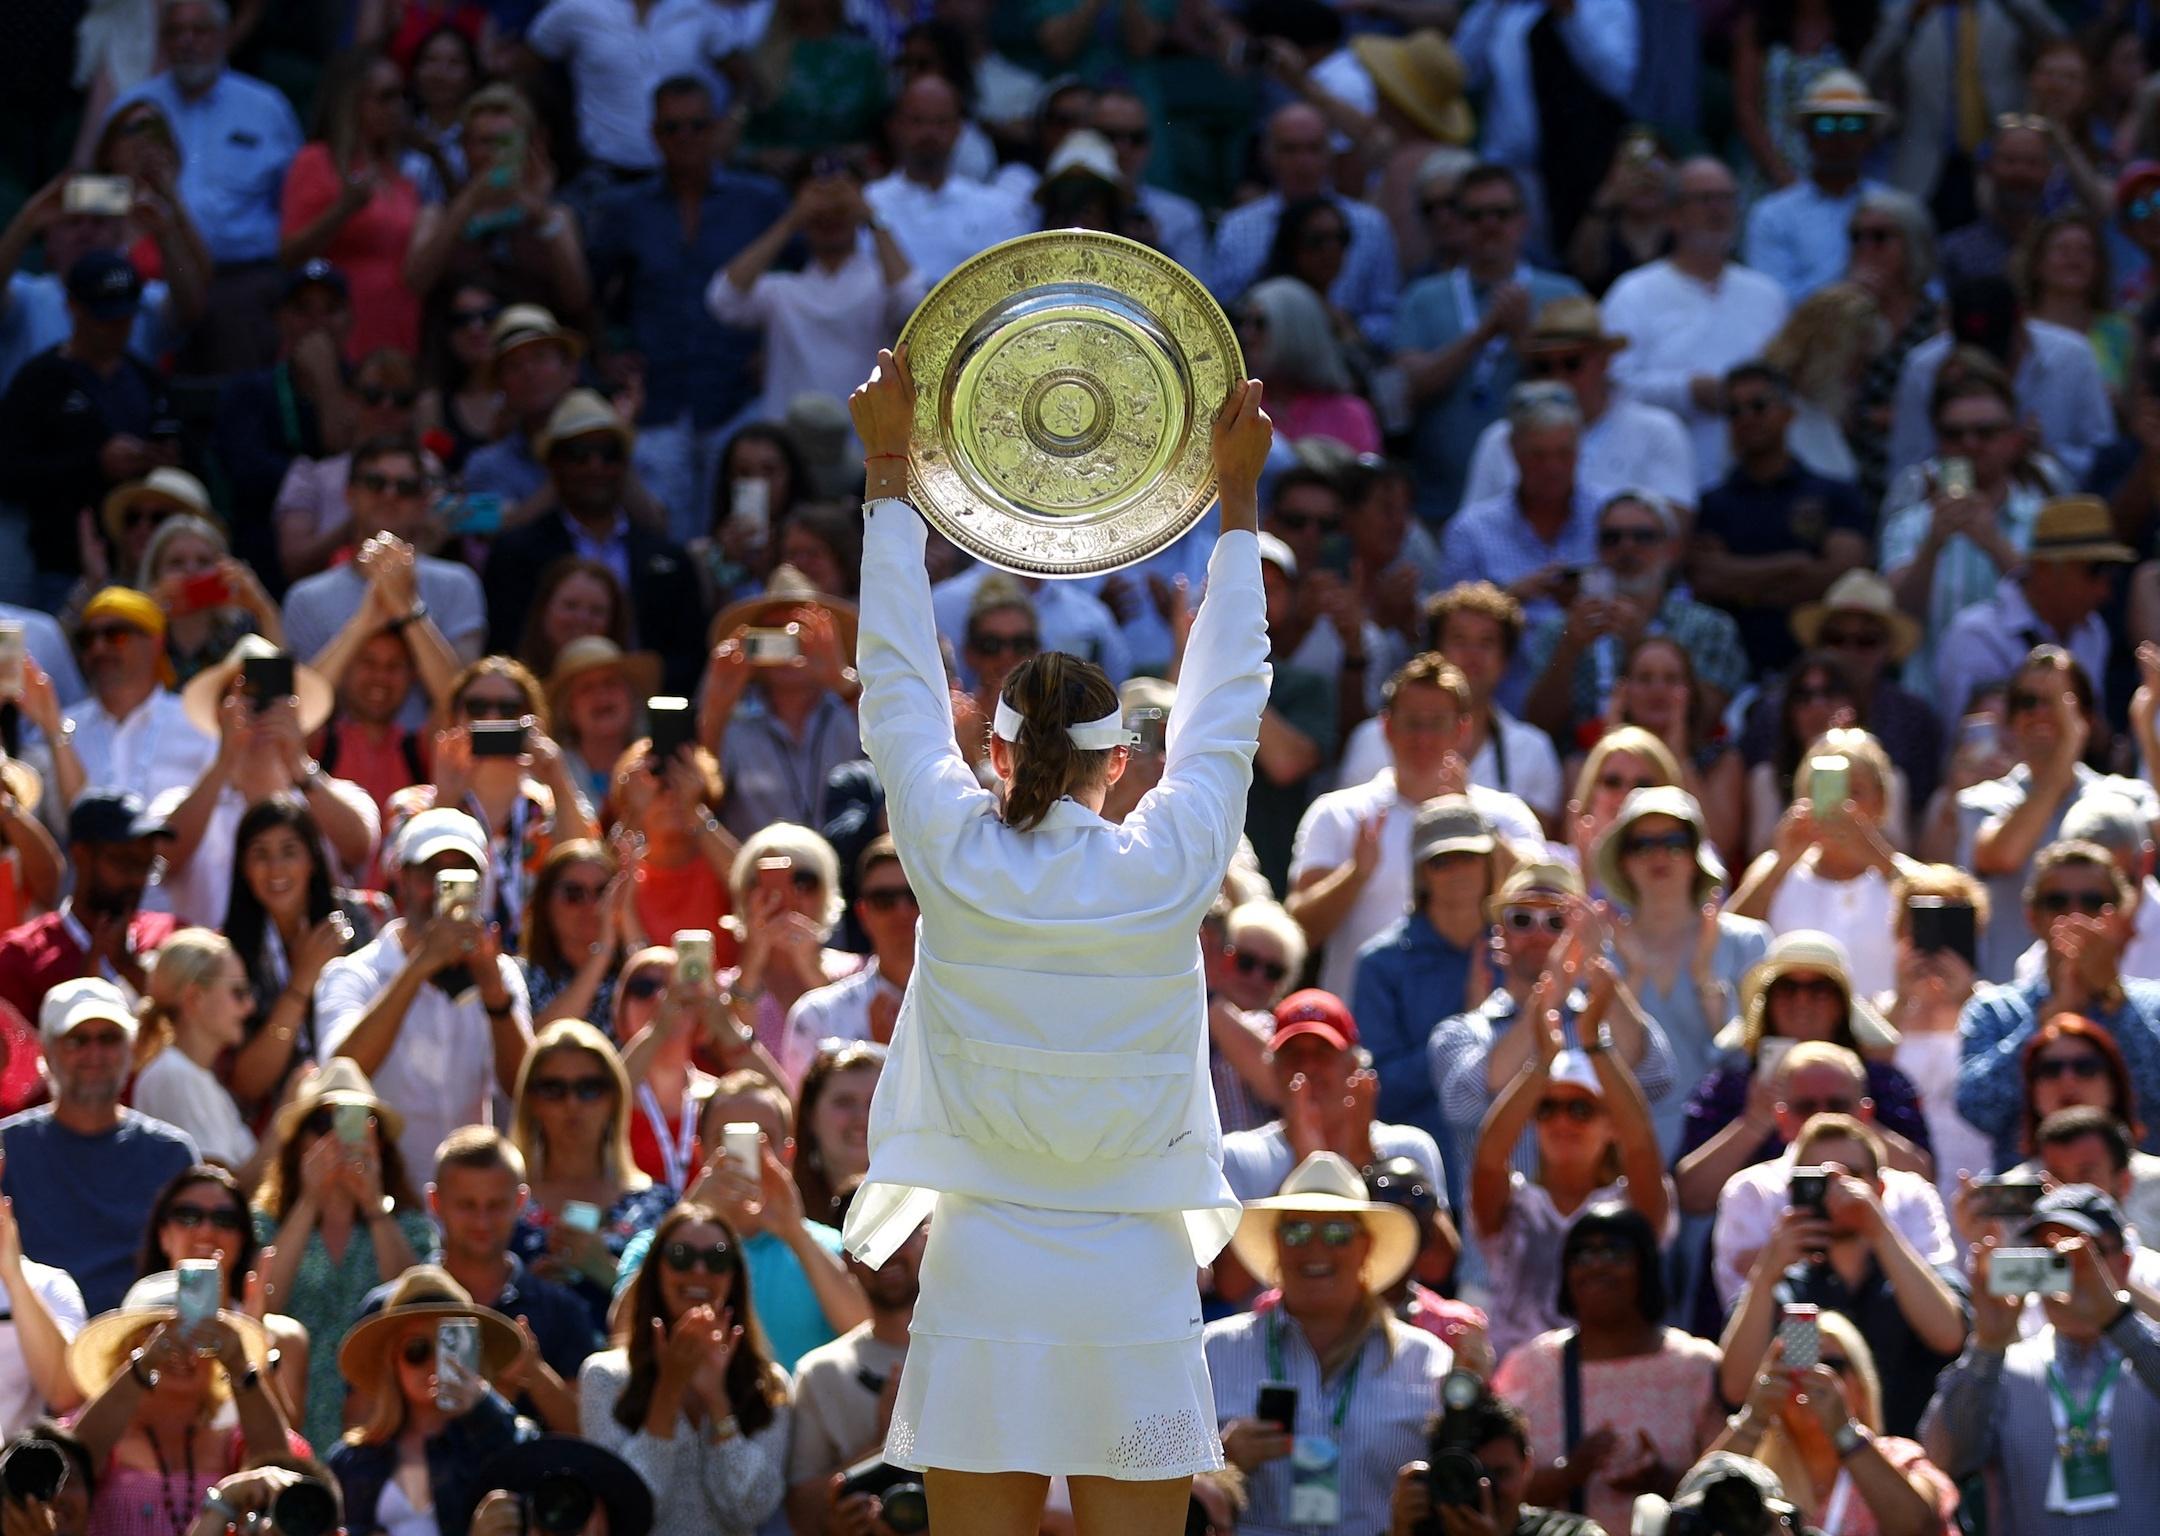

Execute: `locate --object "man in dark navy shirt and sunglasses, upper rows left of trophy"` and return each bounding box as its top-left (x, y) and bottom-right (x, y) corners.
top-left (588, 76), bottom-right (788, 542)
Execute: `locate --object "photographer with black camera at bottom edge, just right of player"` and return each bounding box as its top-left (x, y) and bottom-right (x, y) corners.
top-left (1387, 1391), bottom-right (1605, 1536)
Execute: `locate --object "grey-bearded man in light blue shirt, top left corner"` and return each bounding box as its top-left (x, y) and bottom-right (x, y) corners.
top-left (114, 0), bottom-right (302, 374)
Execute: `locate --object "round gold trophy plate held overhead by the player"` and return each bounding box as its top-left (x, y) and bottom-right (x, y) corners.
top-left (901, 229), bottom-right (1244, 577)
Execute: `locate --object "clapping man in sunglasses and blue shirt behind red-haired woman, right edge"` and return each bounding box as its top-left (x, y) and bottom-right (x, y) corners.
top-left (1957, 843), bottom-right (2160, 1167)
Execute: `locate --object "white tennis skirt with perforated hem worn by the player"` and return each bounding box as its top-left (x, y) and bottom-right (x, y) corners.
top-left (886, 1195), bottom-right (1223, 1482)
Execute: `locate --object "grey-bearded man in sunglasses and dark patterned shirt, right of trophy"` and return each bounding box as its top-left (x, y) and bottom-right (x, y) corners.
top-left (1523, 490), bottom-right (1750, 741)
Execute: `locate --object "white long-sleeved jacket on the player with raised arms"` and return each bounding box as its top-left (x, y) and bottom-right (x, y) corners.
top-left (845, 499), bottom-right (1270, 1264)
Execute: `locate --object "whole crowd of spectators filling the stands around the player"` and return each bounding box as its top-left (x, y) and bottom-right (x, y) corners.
top-left (16, 0), bottom-right (2160, 1536)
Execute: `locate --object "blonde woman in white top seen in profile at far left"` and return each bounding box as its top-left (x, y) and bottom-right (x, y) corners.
top-left (134, 929), bottom-right (261, 1184)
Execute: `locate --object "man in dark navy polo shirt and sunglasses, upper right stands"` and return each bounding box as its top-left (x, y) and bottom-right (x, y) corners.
top-left (1689, 361), bottom-right (1873, 672)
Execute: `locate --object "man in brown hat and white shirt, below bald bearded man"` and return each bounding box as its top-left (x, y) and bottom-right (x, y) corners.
top-left (1462, 294), bottom-right (1696, 510)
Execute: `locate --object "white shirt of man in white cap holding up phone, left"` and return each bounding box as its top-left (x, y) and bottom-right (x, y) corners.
top-left (315, 918), bottom-right (534, 1169)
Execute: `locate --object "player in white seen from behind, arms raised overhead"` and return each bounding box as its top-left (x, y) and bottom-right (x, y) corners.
top-left (847, 352), bottom-right (1272, 1536)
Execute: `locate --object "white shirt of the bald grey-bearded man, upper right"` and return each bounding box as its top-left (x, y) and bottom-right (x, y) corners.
top-left (1603, 261), bottom-right (1788, 486)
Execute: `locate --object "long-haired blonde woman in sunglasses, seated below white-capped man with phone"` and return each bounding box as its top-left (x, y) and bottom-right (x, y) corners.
top-left (510, 1020), bottom-right (676, 1326)
